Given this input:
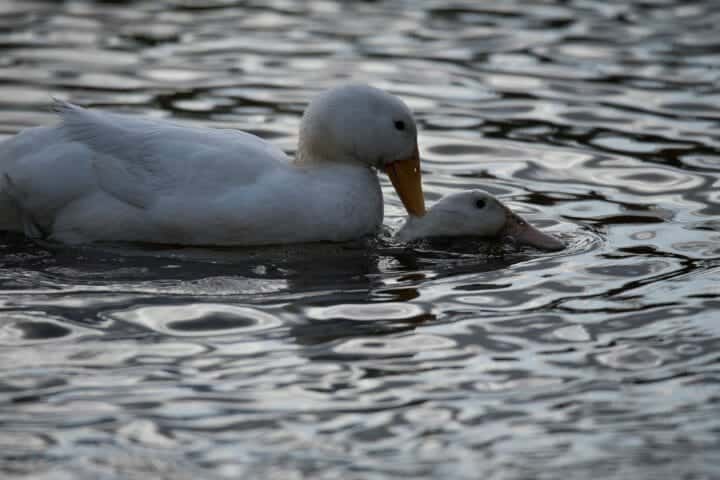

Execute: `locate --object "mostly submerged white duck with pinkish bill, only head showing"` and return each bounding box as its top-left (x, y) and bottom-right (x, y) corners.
top-left (395, 190), bottom-right (565, 251)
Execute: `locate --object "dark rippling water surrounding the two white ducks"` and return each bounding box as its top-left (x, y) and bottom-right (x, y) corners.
top-left (0, 0), bottom-right (720, 480)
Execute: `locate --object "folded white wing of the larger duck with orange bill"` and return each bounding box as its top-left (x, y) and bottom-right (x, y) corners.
top-left (55, 101), bottom-right (289, 208)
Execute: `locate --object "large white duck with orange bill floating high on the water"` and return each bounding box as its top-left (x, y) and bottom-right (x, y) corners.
top-left (0, 85), bottom-right (425, 245)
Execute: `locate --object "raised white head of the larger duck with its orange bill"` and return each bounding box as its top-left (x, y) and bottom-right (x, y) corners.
top-left (298, 85), bottom-right (425, 216)
